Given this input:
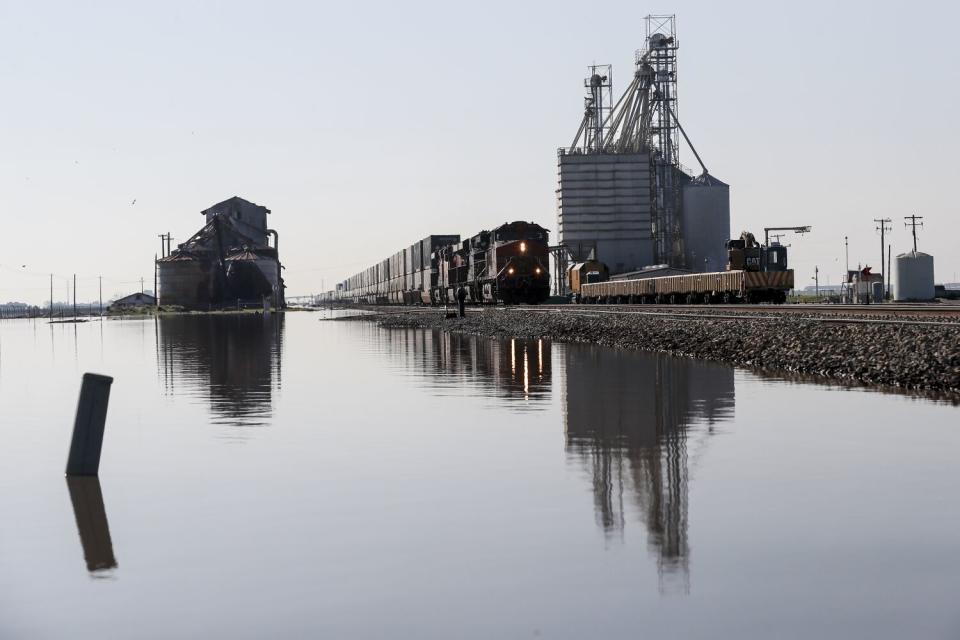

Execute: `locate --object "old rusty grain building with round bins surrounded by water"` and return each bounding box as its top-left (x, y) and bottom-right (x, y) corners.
top-left (157, 196), bottom-right (284, 309)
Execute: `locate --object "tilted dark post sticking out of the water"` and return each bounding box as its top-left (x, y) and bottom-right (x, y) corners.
top-left (67, 373), bottom-right (113, 476)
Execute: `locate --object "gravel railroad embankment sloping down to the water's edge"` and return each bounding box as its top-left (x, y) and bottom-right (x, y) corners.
top-left (346, 309), bottom-right (960, 399)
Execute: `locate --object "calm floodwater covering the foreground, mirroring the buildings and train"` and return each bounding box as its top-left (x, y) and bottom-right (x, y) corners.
top-left (0, 313), bottom-right (960, 639)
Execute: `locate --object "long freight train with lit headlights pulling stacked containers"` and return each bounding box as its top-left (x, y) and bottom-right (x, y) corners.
top-left (330, 221), bottom-right (550, 305)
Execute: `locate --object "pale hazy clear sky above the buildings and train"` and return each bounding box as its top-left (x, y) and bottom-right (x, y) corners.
top-left (0, 0), bottom-right (960, 304)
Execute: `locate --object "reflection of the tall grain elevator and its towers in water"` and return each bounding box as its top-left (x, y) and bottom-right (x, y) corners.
top-left (563, 345), bottom-right (734, 589)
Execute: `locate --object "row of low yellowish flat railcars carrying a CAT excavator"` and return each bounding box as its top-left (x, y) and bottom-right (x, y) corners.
top-left (567, 231), bottom-right (793, 304)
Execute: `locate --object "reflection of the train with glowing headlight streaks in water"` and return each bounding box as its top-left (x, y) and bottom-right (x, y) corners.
top-left (367, 326), bottom-right (551, 408)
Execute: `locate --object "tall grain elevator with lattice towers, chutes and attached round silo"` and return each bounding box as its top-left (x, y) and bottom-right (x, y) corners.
top-left (557, 16), bottom-right (730, 273)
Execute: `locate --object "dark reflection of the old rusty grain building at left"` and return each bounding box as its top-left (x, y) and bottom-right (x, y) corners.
top-left (157, 314), bottom-right (284, 426)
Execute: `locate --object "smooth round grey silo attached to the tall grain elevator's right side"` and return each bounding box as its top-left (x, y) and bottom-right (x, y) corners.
top-left (680, 173), bottom-right (730, 271)
